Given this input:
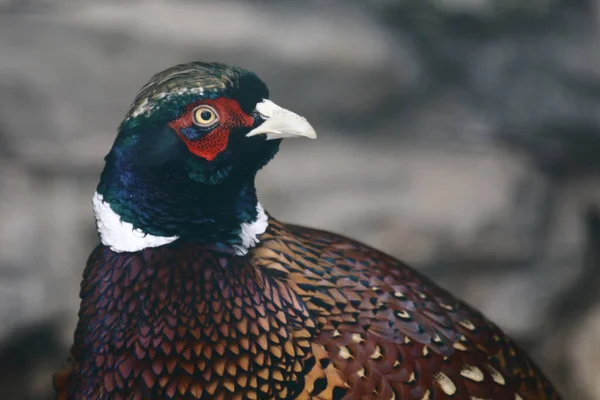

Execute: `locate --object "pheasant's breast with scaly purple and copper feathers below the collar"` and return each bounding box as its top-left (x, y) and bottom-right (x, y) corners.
top-left (63, 241), bottom-right (315, 399)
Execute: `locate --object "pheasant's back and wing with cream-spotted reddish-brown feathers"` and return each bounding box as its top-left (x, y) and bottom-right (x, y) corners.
top-left (254, 220), bottom-right (558, 400)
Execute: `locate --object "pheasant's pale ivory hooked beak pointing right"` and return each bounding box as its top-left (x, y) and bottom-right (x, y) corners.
top-left (246, 99), bottom-right (317, 140)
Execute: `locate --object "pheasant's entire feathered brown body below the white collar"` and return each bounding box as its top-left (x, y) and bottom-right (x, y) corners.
top-left (55, 219), bottom-right (559, 400)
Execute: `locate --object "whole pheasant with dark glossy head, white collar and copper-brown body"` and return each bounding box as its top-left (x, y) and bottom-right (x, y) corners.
top-left (54, 62), bottom-right (560, 400)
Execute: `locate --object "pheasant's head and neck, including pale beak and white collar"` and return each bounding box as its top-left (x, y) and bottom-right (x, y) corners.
top-left (94, 62), bottom-right (316, 254)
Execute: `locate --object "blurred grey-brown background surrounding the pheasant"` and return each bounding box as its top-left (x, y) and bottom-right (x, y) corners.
top-left (0, 0), bottom-right (600, 400)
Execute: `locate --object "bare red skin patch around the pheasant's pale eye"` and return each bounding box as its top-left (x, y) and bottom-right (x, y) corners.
top-left (169, 97), bottom-right (254, 161)
